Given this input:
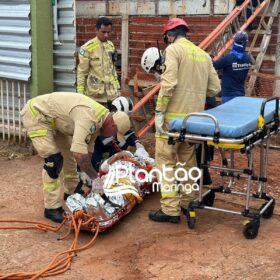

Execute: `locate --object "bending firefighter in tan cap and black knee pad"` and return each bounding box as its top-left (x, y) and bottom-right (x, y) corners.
top-left (21, 92), bottom-right (131, 222)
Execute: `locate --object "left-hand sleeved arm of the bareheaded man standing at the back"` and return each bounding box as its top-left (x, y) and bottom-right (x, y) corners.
top-left (77, 48), bottom-right (90, 93)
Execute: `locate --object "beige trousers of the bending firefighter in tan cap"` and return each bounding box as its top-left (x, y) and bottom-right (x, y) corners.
top-left (21, 108), bottom-right (79, 209)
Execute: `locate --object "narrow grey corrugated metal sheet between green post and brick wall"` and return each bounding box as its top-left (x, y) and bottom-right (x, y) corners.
top-left (53, 0), bottom-right (76, 92)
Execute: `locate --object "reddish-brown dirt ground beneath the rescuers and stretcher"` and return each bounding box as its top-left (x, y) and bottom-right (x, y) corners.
top-left (0, 144), bottom-right (280, 280)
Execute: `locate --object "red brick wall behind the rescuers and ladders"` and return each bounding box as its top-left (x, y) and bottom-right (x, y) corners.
top-left (76, 16), bottom-right (278, 96)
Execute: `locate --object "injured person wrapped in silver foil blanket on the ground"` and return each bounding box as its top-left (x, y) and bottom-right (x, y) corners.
top-left (66, 151), bottom-right (154, 230)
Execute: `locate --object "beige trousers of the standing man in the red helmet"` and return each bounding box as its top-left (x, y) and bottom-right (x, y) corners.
top-left (155, 138), bottom-right (198, 216)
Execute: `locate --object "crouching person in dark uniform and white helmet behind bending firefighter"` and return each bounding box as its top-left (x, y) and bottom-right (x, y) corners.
top-left (91, 96), bottom-right (149, 171)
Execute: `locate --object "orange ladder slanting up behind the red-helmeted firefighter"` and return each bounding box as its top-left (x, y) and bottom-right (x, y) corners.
top-left (132, 0), bottom-right (274, 138)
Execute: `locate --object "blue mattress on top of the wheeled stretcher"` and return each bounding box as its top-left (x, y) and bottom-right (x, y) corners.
top-left (170, 97), bottom-right (276, 138)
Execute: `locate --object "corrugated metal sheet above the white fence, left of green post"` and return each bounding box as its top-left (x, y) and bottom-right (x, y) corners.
top-left (0, 0), bottom-right (31, 81)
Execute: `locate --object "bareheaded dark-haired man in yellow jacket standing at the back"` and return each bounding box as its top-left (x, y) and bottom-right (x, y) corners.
top-left (77, 17), bottom-right (120, 105)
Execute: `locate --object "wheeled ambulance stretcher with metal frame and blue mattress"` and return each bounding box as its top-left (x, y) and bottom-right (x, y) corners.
top-left (167, 97), bottom-right (279, 239)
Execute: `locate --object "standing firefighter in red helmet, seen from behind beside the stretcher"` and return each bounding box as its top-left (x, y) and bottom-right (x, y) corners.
top-left (149, 18), bottom-right (221, 223)
